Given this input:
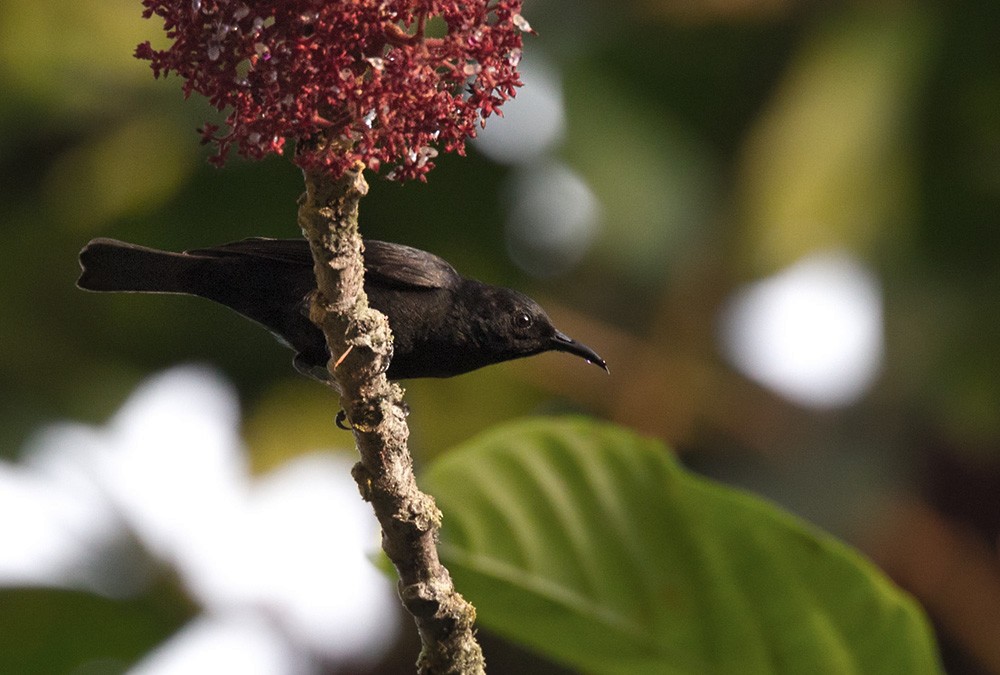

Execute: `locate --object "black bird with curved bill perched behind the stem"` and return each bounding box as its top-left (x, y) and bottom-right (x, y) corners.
top-left (77, 238), bottom-right (608, 382)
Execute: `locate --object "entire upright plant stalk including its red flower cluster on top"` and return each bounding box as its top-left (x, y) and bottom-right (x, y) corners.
top-left (136, 0), bottom-right (533, 673)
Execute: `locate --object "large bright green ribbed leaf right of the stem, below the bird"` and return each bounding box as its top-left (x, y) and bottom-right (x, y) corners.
top-left (424, 418), bottom-right (940, 675)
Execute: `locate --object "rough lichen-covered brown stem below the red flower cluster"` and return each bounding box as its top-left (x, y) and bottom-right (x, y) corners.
top-left (299, 167), bottom-right (484, 673)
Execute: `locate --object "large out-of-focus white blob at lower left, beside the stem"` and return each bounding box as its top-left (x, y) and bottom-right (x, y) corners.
top-left (0, 367), bottom-right (398, 675)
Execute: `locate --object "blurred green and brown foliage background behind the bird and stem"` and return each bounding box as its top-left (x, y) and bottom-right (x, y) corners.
top-left (0, 0), bottom-right (1000, 673)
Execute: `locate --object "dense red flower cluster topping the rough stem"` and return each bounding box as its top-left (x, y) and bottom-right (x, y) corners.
top-left (136, 0), bottom-right (531, 179)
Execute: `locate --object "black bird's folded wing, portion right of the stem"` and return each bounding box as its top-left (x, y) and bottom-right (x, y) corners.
top-left (364, 239), bottom-right (462, 289)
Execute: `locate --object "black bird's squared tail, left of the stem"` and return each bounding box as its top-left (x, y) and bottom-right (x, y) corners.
top-left (76, 238), bottom-right (195, 293)
